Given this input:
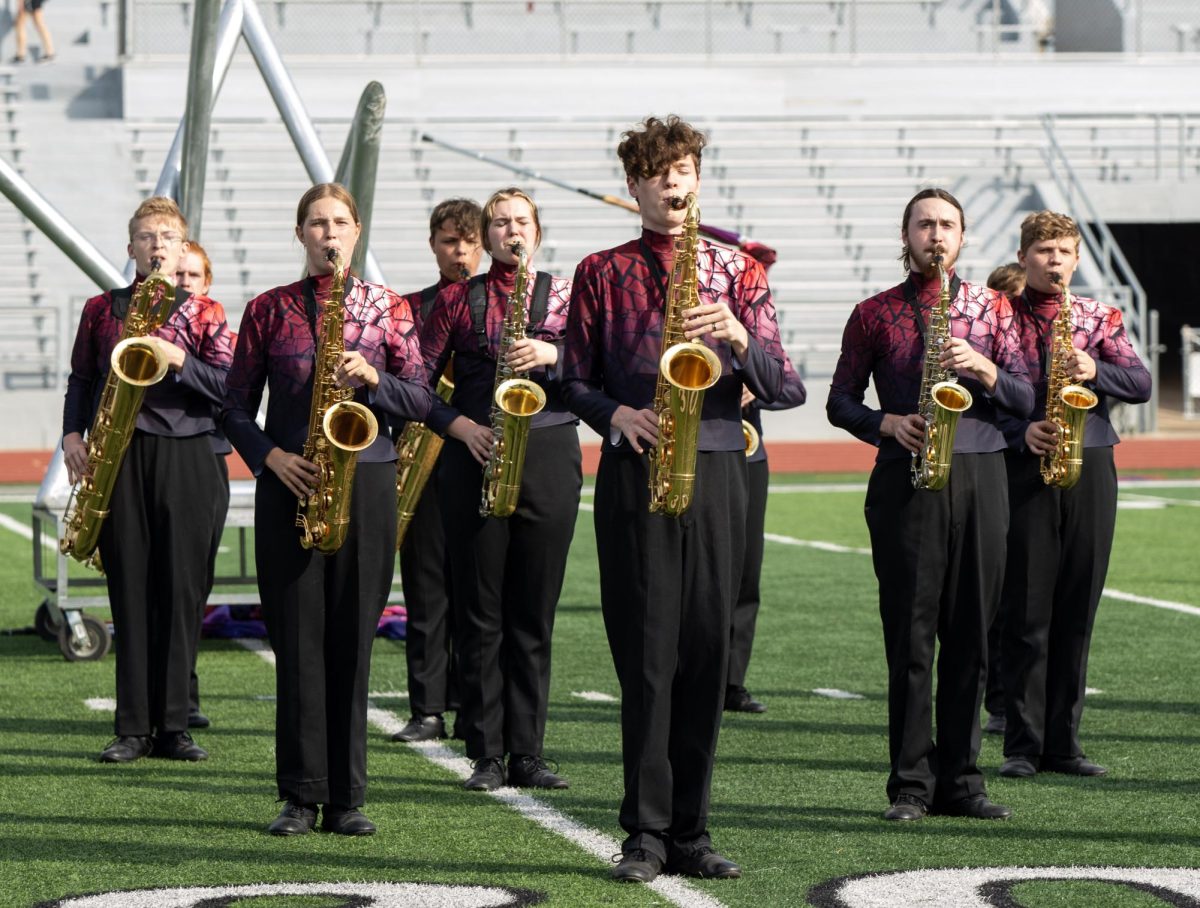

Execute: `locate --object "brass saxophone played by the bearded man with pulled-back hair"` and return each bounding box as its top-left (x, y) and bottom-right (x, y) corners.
top-left (912, 251), bottom-right (972, 492)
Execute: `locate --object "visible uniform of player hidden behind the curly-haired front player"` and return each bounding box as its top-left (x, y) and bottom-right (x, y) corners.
top-left (725, 357), bottom-right (808, 712)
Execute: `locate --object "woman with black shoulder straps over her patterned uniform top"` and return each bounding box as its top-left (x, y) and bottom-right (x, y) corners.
top-left (421, 187), bottom-right (582, 790)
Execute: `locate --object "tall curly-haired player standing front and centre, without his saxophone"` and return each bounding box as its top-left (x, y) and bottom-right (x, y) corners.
top-left (563, 116), bottom-right (784, 883)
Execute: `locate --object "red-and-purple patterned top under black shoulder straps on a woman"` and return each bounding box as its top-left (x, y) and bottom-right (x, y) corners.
top-left (421, 260), bottom-right (575, 435)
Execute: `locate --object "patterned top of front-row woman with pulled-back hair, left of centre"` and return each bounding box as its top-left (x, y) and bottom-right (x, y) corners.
top-left (222, 268), bottom-right (431, 476)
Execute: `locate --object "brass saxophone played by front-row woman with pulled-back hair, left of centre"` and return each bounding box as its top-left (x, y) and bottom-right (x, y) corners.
top-left (296, 249), bottom-right (379, 555)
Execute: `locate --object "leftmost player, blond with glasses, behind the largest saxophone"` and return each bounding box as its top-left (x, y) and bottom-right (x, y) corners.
top-left (62, 197), bottom-right (233, 763)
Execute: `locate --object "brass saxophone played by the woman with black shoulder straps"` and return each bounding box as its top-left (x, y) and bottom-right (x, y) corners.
top-left (479, 242), bottom-right (546, 517)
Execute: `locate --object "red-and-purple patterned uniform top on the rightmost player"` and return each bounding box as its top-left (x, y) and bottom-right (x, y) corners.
top-left (1001, 287), bottom-right (1151, 451)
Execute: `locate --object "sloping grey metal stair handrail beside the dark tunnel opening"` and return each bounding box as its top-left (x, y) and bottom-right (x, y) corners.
top-left (1042, 114), bottom-right (1158, 432)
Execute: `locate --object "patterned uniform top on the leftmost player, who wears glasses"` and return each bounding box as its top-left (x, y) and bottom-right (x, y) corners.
top-left (62, 275), bottom-right (235, 438)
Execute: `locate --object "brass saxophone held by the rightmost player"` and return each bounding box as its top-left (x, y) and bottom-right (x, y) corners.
top-left (1042, 273), bottom-right (1099, 488)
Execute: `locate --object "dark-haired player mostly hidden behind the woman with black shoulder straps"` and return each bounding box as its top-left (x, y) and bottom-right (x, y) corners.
top-left (392, 199), bottom-right (484, 741)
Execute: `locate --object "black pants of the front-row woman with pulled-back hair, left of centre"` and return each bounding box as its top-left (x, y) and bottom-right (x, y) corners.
top-left (254, 463), bottom-right (396, 807)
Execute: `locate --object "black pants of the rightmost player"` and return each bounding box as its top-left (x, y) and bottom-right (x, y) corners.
top-left (1002, 447), bottom-right (1117, 763)
